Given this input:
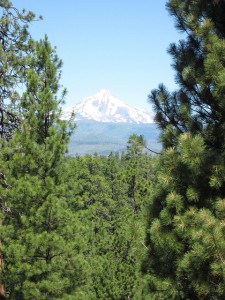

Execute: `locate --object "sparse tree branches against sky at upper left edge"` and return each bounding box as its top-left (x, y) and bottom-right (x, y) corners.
top-left (0, 0), bottom-right (35, 139)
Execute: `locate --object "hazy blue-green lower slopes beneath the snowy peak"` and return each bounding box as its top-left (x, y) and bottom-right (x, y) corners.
top-left (69, 120), bottom-right (161, 155)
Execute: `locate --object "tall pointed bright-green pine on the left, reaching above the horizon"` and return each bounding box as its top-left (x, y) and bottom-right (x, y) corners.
top-left (1, 37), bottom-right (87, 300)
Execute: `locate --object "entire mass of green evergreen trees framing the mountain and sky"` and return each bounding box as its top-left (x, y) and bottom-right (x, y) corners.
top-left (0, 0), bottom-right (225, 300)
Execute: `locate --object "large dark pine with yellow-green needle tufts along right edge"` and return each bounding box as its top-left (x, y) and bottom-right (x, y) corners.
top-left (142, 0), bottom-right (225, 299)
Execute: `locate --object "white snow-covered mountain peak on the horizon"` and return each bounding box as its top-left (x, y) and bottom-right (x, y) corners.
top-left (63, 89), bottom-right (153, 124)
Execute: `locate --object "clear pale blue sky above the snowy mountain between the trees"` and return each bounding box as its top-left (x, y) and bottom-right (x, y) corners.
top-left (12, 0), bottom-right (181, 111)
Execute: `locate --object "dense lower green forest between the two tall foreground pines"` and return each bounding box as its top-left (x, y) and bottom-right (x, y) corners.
top-left (64, 153), bottom-right (152, 299)
